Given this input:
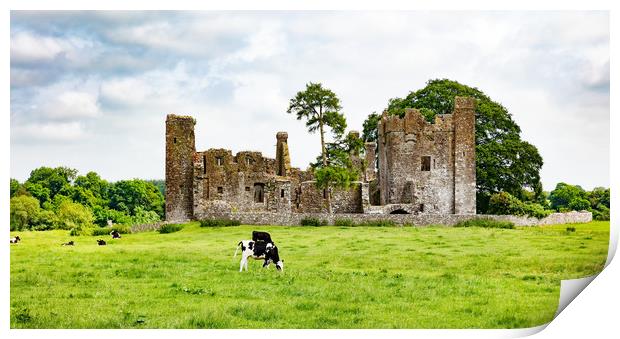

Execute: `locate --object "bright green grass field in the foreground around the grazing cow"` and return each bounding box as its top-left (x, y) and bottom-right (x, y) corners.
top-left (10, 222), bottom-right (609, 328)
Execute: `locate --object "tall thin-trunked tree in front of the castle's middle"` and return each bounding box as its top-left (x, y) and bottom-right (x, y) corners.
top-left (286, 83), bottom-right (350, 213)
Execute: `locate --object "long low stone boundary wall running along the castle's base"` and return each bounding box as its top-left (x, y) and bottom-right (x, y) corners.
top-left (196, 212), bottom-right (592, 226)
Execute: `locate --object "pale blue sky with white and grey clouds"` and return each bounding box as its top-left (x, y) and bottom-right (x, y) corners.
top-left (10, 11), bottom-right (610, 189)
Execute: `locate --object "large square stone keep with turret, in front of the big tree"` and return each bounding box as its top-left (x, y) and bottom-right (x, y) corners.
top-left (378, 97), bottom-right (476, 214)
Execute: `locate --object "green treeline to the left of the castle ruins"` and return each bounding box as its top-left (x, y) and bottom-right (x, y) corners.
top-left (10, 167), bottom-right (164, 235)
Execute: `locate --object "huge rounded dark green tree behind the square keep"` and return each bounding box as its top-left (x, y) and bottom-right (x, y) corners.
top-left (364, 79), bottom-right (543, 213)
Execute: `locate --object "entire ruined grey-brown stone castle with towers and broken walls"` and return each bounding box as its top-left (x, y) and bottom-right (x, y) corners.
top-left (166, 97), bottom-right (476, 221)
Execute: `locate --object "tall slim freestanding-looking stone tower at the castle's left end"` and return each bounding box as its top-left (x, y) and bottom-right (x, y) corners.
top-left (166, 114), bottom-right (196, 221)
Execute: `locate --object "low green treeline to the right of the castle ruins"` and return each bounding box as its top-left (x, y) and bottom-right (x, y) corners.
top-left (487, 182), bottom-right (610, 220)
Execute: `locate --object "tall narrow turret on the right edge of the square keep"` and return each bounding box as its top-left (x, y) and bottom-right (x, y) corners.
top-left (452, 97), bottom-right (476, 214)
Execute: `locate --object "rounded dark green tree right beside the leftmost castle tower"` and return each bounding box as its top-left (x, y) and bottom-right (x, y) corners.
top-left (109, 179), bottom-right (164, 218)
